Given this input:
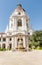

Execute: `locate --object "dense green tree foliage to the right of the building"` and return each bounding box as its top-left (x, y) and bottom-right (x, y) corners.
top-left (30, 31), bottom-right (42, 48)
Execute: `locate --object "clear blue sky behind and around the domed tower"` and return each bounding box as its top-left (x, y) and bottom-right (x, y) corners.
top-left (0, 0), bottom-right (42, 32)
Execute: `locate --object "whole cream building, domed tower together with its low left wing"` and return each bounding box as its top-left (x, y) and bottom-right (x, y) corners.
top-left (0, 4), bottom-right (30, 50)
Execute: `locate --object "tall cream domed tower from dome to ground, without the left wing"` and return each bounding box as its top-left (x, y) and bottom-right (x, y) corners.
top-left (8, 4), bottom-right (29, 49)
